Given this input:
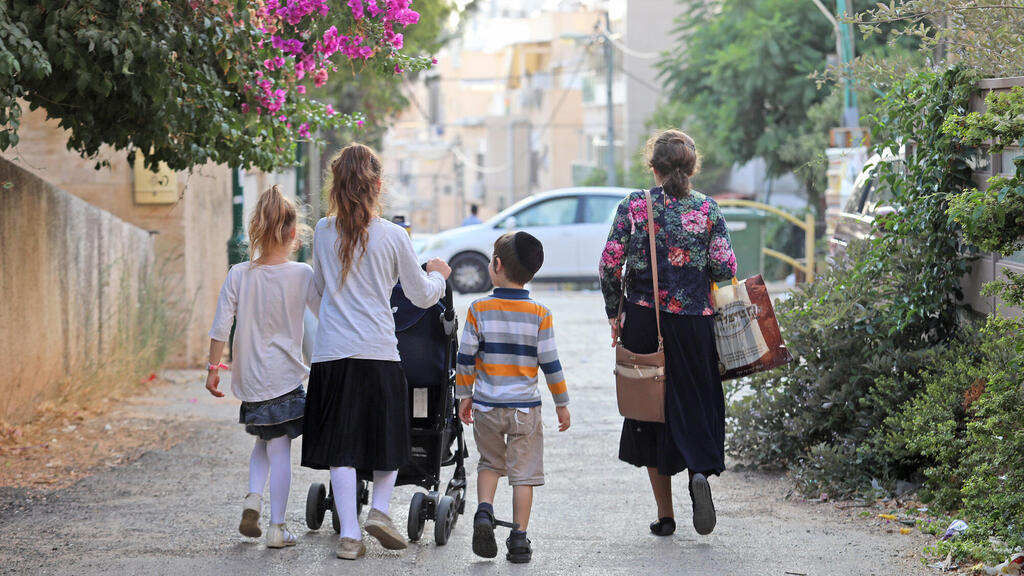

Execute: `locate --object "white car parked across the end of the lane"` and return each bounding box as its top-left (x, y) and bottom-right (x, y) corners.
top-left (419, 187), bottom-right (633, 293)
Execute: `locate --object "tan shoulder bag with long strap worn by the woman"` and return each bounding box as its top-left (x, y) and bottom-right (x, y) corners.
top-left (615, 191), bottom-right (665, 422)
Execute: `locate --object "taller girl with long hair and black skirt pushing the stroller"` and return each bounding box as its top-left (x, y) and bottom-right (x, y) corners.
top-left (302, 143), bottom-right (452, 560)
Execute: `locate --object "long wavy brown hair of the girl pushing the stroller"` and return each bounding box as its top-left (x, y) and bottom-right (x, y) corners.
top-left (328, 143), bottom-right (383, 284)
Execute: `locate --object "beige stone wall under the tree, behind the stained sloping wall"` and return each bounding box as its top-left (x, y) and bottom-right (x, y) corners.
top-left (0, 106), bottom-right (231, 366)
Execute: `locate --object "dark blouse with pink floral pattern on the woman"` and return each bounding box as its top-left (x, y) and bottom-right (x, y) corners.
top-left (600, 187), bottom-right (736, 318)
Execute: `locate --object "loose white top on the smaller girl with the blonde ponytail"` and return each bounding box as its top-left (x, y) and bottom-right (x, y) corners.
top-left (210, 262), bottom-right (319, 402)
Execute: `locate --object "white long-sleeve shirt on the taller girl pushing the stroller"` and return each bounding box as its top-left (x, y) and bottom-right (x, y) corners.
top-left (312, 216), bottom-right (444, 362)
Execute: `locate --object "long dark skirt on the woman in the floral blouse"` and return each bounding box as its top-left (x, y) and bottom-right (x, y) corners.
top-left (618, 302), bottom-right (725, 476)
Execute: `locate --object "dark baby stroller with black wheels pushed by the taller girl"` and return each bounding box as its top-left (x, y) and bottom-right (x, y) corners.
top-left (306, 283), bottom-right (469, 546)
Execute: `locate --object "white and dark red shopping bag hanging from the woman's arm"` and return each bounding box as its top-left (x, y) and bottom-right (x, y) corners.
top-left (711, 274), bottom-right (793, 380)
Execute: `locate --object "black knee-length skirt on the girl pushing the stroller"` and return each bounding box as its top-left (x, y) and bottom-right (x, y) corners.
top-left (302, 358), bottom-right (410, 470)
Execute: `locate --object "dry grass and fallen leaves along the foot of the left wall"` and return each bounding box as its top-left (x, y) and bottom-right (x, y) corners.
top-left (0, 260), bottom-right (191, 491)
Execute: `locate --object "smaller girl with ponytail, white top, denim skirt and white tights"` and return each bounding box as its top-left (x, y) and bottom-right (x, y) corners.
top-left (206, 186), bottom-right (319, 548)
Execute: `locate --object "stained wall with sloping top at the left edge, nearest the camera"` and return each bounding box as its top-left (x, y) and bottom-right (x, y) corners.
top-left (0, 159), bottom-right (155, 422)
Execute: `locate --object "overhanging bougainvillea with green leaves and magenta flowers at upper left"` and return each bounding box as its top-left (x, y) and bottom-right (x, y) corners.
top-left (0, 0), bottom-right (431, 170)
